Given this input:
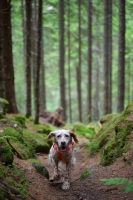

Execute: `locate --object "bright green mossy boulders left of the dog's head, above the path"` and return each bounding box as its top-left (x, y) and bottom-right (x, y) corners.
top-left (0, 115), bottom-right (53, 164)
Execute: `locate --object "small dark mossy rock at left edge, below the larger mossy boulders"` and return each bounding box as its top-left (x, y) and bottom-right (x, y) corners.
top-left (0, 138), bottom-right (14, 165)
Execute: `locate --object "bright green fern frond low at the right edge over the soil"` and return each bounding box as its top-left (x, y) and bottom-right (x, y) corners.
top-left (100, 177), bottom-right (133, 192)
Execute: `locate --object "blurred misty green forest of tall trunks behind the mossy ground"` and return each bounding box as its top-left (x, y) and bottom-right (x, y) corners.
top-left (0, 0), bottom-right (133, 123)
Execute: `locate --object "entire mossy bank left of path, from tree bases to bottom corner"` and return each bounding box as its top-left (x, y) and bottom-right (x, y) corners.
top-left (0, 115), bottom-right (54, 199)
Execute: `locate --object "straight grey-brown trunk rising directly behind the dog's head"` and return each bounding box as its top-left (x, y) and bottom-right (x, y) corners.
top-left (59, 0), bottom-right (66, 120)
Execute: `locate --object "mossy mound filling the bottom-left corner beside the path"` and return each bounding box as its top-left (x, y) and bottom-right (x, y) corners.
top-left (0, 164), bottom-right (30, 199)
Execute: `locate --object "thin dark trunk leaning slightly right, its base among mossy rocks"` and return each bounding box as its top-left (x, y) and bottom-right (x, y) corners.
top-left (34, 0), bottom-right (43, 124)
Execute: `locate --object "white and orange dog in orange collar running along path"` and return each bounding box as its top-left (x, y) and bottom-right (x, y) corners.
top-left (47, 129), bottom-right (78, 190)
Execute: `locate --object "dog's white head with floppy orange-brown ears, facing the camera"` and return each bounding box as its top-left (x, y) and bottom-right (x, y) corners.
top-left (47, 129), bottom-right (78, 151)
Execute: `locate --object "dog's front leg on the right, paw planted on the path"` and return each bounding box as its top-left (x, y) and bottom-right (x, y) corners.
top-left (62, 163), bottom-right (72, 190)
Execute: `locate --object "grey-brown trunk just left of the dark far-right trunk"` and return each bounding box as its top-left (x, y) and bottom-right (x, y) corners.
top-left (104, 0), bottom-right (112, 114)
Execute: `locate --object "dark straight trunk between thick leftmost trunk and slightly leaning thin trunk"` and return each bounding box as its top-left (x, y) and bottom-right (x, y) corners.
top-left (25, 0), bottom-right (32, 117)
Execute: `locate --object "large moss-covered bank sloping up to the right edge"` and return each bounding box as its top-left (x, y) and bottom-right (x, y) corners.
top-left (88, 101), bottom-right (133, 165)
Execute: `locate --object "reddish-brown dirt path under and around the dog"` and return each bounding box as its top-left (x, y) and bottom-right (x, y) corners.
top-left (15, 139), bottom-right (133, 200)
